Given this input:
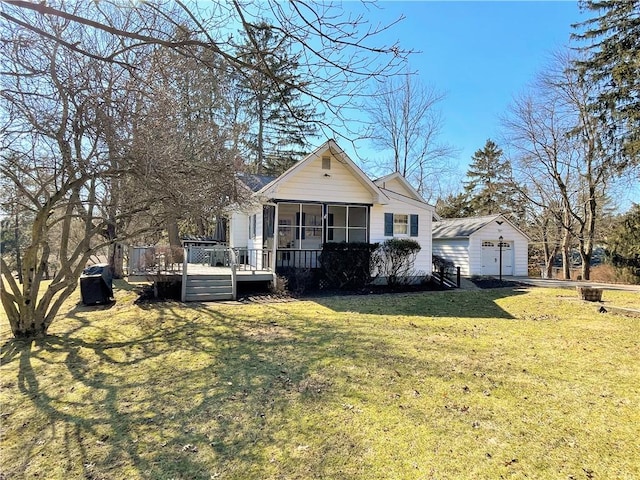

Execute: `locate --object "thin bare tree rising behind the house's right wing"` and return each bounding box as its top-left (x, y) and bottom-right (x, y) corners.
top-left (364, 73), bottom-right (454, 200)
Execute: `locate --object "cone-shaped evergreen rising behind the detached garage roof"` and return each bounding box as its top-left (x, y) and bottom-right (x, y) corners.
top-left (464, 140), bottom-right (521, 215)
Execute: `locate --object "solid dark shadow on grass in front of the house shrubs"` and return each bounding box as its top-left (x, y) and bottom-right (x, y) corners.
top-left (308, 288), bottom-right (527, 319)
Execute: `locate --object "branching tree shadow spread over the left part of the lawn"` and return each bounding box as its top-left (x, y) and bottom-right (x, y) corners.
top-left (2, 303), bottom-right (396, 480)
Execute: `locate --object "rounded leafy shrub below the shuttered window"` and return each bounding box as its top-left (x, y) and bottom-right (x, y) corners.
top-left (374, 238), bottom-right (421, 287)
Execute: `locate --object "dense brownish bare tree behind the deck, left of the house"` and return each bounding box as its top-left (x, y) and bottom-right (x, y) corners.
top-left (130, 33), bottom-right (246, 246)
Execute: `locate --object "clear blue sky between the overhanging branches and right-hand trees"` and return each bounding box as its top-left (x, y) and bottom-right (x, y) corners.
top-left (343, 1), bottom-right (587, 184)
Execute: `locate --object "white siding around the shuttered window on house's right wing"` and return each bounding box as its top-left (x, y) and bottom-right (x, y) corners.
top-left (370, 200), bottom-right (433, 275)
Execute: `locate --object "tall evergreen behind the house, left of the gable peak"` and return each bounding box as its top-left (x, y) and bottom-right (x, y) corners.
top-left (237, 22), bottom-right (317, 175)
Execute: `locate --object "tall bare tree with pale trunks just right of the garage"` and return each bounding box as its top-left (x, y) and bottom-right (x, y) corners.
top-left (505, 51), bottom-right (616, 279)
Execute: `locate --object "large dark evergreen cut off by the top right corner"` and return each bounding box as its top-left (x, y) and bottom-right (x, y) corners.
top-left (573, 0), bottom-right (640, 165)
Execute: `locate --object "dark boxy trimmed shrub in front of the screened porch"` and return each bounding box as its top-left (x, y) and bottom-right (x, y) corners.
top-left (320, 242), bottom-right (378, 289)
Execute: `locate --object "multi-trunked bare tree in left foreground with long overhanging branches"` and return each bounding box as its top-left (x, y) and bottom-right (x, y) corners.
top-left (0, 0), bottom-right (416, 336)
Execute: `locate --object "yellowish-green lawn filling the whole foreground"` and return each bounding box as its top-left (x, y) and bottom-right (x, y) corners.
top-left (0, 288), bottom-right (640, 480)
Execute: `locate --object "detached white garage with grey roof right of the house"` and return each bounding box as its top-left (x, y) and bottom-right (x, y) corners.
top-left (433, 215), bottom-right (529, 276)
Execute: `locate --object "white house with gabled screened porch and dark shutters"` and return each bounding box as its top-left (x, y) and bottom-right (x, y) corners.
top-left (229, 140), bottom-right (434, 275)
